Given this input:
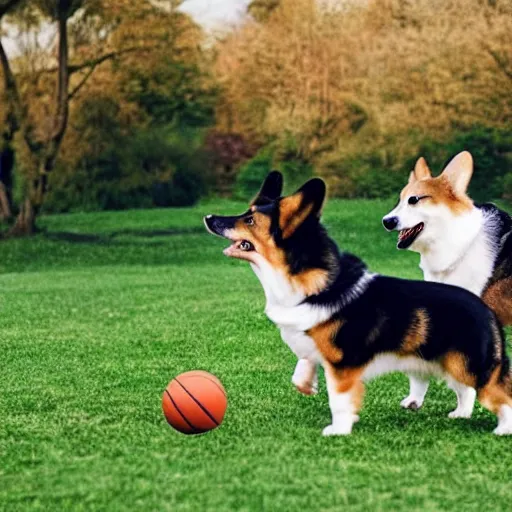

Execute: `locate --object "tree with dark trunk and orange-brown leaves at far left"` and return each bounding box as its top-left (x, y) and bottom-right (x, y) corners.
top-left (0, 0), bottom-right (203, 235)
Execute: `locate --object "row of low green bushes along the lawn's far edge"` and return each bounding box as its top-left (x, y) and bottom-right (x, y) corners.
top-left (44, 126), bottom-right (512, 212)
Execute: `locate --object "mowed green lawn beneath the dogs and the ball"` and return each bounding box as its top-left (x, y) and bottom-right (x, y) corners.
top-left (0, 201), bottom-right (512, 512)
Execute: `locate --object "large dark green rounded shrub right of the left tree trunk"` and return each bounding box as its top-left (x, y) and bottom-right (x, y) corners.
top-left (44, 130), bottom-right (208, 216)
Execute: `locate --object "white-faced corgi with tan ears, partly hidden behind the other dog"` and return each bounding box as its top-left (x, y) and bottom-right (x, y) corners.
top-left (382, 151), bottom-right (512, 408)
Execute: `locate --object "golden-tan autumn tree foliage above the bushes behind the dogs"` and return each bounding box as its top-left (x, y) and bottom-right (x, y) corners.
top-left (215, 0), bottom-right (512, 186)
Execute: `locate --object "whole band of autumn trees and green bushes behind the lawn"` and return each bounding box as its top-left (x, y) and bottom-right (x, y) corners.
top-left (0, 0), bottom-right (512, 232)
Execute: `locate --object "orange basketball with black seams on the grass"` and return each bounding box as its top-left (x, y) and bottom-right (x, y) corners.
top-left (162, 370), bottom-right (228, 434)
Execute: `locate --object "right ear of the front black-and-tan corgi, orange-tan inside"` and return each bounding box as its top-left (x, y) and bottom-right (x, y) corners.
top-left (279, 178), bottom-right (326, 239)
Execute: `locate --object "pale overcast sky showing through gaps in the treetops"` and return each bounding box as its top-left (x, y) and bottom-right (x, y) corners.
top-left (2, 0), bottom-right (251, 55)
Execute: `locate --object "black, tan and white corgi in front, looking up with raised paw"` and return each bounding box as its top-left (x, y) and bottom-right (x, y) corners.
top-left (204, 171), bottom-right (512, 435)
